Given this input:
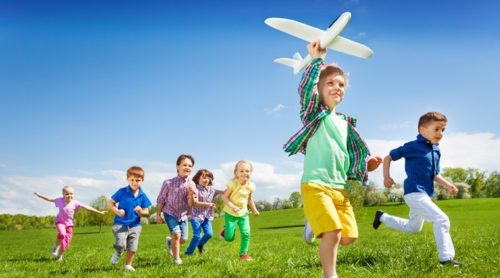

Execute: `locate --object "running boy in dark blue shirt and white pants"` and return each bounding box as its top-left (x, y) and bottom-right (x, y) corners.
top-left (373, 112), bottom-right (462, 266)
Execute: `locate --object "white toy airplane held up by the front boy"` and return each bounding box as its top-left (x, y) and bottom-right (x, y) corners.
top-left (265, 12), bottom-right (373, 74)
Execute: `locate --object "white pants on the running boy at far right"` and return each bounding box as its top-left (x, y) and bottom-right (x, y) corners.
top-left (380, 193), bottom-right (455, 261)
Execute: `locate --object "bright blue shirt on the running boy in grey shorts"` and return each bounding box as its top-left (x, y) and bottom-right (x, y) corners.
top-left (111, 186), bottom-right (151, 227)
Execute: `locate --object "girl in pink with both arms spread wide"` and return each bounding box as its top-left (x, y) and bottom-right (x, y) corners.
top-left (34, 186), bottom-right (104, 261)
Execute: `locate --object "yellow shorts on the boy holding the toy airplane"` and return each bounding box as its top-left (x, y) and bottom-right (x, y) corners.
top-left (300, 182), bottom-right (358, 238)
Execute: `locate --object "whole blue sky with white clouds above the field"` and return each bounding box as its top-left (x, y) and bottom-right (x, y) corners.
top-left (0, 0), bottom-right (500, 215)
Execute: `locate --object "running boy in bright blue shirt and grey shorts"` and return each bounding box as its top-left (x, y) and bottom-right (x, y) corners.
top-left (108, 166), bottom-right (151, 271)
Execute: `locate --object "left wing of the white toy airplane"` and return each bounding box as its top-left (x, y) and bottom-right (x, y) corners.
top-left (264, 17), bottom-right (325, 42)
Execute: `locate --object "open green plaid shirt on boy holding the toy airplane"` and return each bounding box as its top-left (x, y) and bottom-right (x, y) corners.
top-left (283, 58), bottom-right (370, 183)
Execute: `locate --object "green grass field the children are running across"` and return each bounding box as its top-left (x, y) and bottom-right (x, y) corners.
top-left (0, 199), bottom-right (500, 277)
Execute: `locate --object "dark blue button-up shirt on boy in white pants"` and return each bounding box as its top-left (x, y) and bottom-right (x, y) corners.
top-left (389, 134), bottom-right (441, 197)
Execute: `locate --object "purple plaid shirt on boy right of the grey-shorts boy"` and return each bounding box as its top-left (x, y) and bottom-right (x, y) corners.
top-left (156, 176), bottom-right (194, 221)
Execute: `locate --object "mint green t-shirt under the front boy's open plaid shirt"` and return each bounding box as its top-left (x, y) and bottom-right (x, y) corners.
top-left (301, 112), bottom-right (349, 189)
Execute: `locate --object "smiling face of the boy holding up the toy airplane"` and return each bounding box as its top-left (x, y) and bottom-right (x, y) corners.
top-left (318, 72), bottom-right (346, 111)
